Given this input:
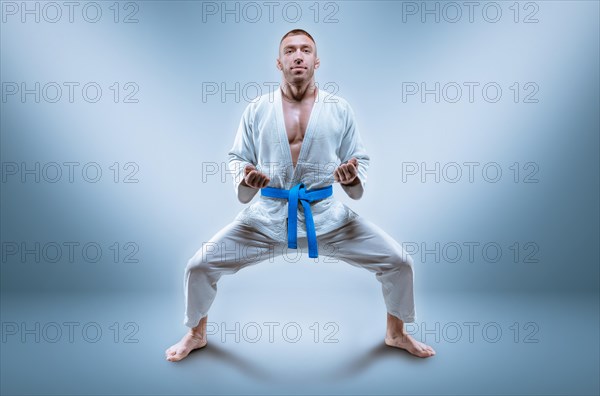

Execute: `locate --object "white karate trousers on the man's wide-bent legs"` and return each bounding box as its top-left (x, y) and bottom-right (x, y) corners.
top-left (184, 216), bottom-right (416, 328)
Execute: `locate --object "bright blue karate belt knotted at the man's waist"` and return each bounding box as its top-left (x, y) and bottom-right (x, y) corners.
top-left (260, 183), bottom-right (333, 258)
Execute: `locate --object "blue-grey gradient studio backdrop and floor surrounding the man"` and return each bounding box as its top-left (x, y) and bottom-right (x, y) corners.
top-left (0, 1), bottom-right (600, 394)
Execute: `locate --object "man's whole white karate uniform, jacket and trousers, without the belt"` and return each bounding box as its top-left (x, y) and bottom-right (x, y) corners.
top-left (184, 89), bottom-right (415, 328)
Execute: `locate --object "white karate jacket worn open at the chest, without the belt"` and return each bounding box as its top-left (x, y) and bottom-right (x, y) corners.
top-left (228, 88), bottom-right (369, 241)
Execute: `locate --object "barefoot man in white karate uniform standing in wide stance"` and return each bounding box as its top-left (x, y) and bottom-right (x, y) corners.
top-left (165, 29), bottom-right (435, 361)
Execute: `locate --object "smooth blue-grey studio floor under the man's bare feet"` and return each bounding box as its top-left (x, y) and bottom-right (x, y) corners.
top-left (1, 290), bottom-right (599, 395)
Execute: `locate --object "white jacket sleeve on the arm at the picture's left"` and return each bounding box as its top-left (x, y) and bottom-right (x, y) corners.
top-left (228, 104), bottom-right (258, 203)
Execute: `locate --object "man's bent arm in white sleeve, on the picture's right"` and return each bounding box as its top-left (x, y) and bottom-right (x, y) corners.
top-left (336, 105), bottom-right (371, 199)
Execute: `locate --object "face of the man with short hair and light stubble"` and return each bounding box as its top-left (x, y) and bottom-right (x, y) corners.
top-left (277, 34), bottom-right (319, 84)
